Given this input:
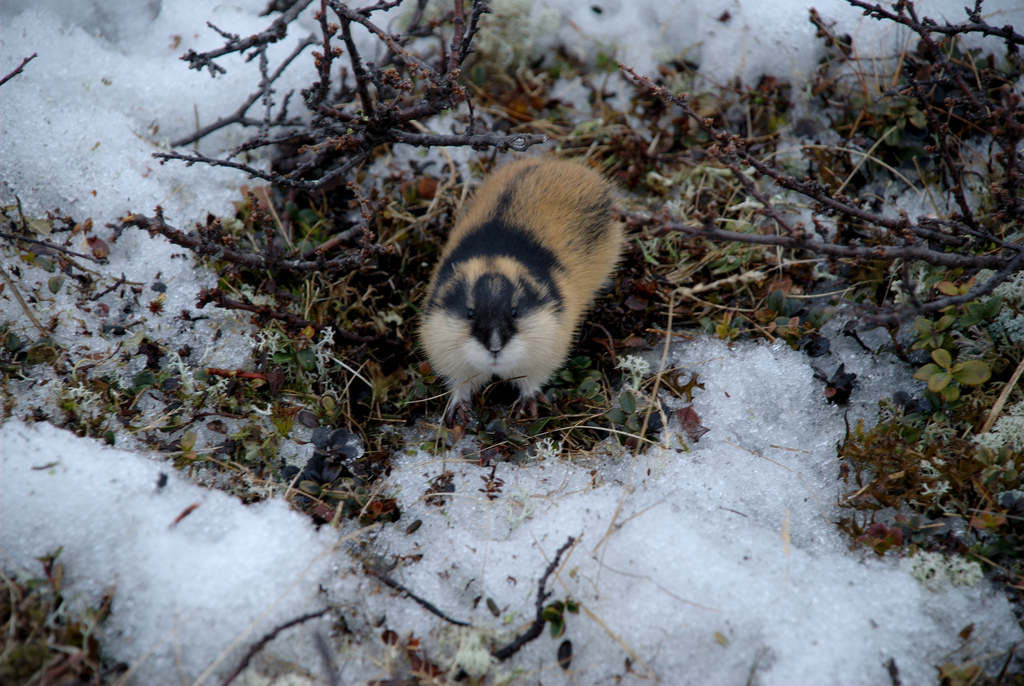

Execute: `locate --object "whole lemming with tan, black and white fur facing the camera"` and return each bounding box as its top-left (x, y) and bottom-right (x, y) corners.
top-left (420, 159), bottom-right (624, 419)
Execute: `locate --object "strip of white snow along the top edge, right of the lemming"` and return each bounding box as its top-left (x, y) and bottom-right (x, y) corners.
top-left (541, 0), bottom-right (1024, 86)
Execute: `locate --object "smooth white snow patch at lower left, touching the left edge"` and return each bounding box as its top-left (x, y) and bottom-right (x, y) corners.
top-left (0, 421), bottom-right (337, 683)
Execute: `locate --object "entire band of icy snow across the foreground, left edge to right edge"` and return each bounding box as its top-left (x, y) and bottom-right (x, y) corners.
top-left (0, 341), bottom-right (1024, 684)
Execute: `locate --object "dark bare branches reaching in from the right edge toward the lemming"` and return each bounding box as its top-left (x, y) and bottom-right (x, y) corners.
top-left (620, 23), bottom-right (1024, 325)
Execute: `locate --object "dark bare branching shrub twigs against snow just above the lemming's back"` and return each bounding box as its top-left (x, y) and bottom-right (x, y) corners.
top-left (154, 0), bottom-right (547, 194)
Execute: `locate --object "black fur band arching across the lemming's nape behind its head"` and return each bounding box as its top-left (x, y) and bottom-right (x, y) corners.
top-left (430, 219), bottom-right (562, 309)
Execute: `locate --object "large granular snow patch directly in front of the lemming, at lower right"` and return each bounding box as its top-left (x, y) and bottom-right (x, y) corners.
top-left (362, 341), bottom-right (1022, 684)
